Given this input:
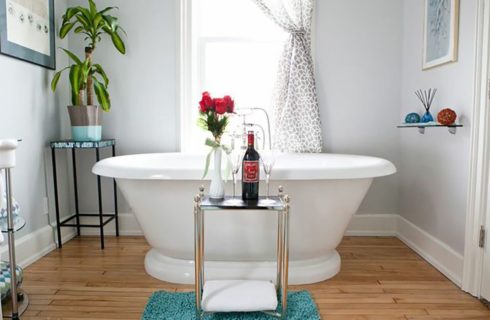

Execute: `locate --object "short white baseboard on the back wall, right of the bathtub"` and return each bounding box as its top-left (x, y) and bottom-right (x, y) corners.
top-left (345, 214), bottom-right (398, 237)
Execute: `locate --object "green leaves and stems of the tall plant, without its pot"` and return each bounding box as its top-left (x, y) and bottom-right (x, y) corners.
top-left (51, 0), bottom-right (126, 111)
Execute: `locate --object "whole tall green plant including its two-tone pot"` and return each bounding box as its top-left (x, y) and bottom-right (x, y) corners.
top-left (51, 0), bottom-right (126, 141)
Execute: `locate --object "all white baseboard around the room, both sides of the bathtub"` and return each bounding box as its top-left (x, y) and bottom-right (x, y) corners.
top-left (0, 213), bottom-right (463, 286)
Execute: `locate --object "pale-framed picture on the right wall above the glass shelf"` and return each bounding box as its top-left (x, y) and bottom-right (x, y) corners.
top-left (422, 0), bottom-right (459, 70)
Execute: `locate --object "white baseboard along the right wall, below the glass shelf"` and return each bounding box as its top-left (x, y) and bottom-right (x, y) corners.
top-left (397, 216), bottom-right (464, 287)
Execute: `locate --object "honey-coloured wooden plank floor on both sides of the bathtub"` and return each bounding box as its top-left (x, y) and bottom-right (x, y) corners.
top-left (22, 237), bottom-right (490, 320)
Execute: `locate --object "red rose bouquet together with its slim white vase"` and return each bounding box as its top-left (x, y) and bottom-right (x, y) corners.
top-left (197, 91), bottom-right (235, 182)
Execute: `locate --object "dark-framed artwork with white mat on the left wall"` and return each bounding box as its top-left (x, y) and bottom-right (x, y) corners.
top-left (0, 0), bottom-right (56, 69)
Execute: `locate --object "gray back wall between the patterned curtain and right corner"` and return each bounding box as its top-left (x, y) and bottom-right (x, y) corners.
top-left (314, 0), bottom-right (403, 214)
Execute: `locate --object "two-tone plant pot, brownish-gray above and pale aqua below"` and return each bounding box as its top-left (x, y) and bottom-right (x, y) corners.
top-left (68, 106), bottom-right (102, 141)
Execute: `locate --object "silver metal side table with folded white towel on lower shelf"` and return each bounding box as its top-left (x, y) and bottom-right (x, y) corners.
top-left (194, 187), bottom-right (290, 319)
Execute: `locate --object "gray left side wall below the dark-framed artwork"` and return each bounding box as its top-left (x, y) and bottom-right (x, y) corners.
top-left (0, 1), bottom-right (69, 236)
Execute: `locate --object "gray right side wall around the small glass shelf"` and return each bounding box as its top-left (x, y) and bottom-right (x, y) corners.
top-left (399, 0), bottom-right (477, 254)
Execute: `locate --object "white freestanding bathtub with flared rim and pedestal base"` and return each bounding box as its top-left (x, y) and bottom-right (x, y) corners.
top-left (92, 153), bottom-right (396, 284)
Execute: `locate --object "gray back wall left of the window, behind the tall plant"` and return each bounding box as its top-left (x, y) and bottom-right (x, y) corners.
top-left (62, 0), bottom-right (180, 212)
